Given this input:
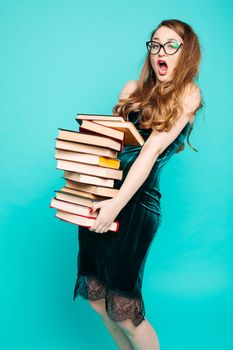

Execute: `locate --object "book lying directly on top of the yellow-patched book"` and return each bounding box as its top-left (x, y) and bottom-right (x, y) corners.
top-left (56, 138), bottom-right (118, 158)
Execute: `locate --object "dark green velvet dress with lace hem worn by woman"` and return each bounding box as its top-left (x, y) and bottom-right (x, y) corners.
top-left (73, 112), bottom-right (191, 326)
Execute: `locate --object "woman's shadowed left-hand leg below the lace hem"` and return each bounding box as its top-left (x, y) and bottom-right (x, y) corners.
top-left (90, 298), bottom-right (134, 350)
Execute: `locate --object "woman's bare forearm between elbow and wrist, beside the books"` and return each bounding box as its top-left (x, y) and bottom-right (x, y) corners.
top-left (114, 148), bottom-right (158, 210)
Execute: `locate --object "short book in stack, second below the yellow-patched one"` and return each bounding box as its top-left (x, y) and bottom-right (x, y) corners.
top-left (64, 170), bottom-right (114, 187)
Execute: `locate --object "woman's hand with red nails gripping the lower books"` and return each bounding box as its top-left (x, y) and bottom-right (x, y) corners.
top-left (89, 198), bottom-right (120, 233)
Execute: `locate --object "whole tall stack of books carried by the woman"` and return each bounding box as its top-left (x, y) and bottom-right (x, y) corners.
top-left (50, 114), bottom-right (144, 232)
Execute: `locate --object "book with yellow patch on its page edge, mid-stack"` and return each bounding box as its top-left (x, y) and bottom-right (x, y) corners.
top-left (55, 148), bottom-right (120, 169)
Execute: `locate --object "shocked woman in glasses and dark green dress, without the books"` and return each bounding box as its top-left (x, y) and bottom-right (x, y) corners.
top-left (74, 20), bottom-right (203, 350)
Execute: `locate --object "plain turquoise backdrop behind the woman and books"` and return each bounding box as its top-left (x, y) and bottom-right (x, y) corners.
top-left (0, 0), bottom-right (233, 350)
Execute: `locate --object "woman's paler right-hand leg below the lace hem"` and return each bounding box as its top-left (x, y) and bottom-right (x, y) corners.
top-left (117, 319), bottom-right (160, 350)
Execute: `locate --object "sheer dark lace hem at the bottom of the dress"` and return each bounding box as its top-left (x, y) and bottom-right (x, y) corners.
top-left (73, 275), bottom-right (145, 326)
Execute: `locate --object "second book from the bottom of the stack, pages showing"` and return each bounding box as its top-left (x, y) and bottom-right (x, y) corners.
top-left (50, 198), bottom-right (98, 218)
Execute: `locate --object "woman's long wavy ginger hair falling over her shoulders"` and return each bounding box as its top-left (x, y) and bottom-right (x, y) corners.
top-left (112, 19), bottom-right (203, 152)
